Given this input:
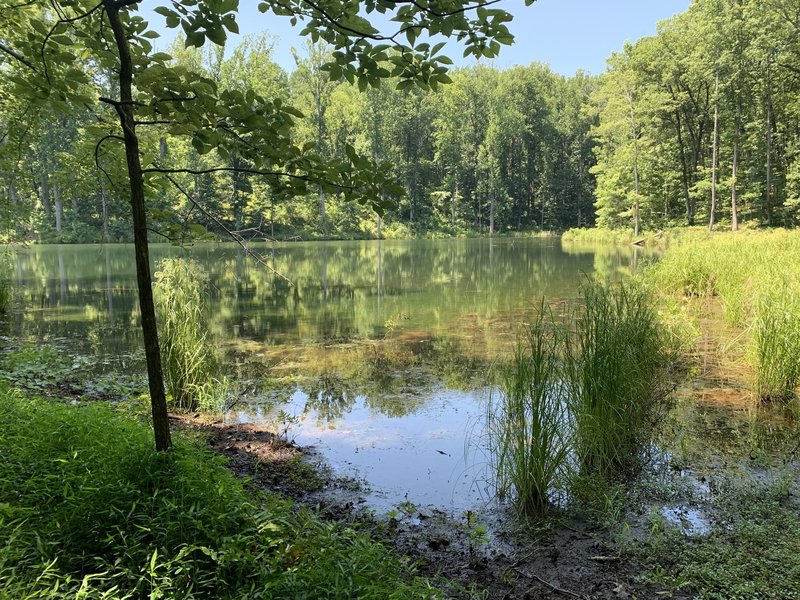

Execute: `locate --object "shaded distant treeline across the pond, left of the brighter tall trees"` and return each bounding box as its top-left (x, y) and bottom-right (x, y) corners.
top-left (0, 36), bottom-right (596, 242)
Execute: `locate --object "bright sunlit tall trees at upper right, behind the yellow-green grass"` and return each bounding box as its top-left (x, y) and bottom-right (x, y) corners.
top-left (592, 0), bottom-right (800, 229)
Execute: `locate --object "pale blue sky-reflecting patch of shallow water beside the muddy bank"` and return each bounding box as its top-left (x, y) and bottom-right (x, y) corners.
top-left (228, 389), bottom-right (491, 513)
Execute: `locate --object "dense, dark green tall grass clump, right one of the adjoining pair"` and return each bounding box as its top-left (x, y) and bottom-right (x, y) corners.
top-left (565, 282), bottom-right (674, 481)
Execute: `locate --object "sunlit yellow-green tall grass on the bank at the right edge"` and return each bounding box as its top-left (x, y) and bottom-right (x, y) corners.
top-left (648, 230), bottom-right (800, 400)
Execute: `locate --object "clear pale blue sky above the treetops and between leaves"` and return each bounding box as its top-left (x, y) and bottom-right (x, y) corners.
top-left (140, 0), bottom-right (690, 75)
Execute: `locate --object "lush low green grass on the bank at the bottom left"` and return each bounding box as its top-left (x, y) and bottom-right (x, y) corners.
top-left (0, 386), bottom-right (439, 599)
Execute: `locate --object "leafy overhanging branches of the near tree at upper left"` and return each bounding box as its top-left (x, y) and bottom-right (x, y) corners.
top-left (0, 0), bottom-right (533, 213)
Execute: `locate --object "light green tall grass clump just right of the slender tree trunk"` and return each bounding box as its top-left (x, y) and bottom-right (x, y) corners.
top-left (153, 258), bottom-right (217, 411)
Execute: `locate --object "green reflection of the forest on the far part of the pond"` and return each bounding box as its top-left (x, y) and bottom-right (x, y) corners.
top-left (10, 239), bottom-right (648, 366)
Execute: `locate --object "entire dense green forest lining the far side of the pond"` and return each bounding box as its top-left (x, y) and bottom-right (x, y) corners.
top-left (0, 0), bottom-right (800, 242)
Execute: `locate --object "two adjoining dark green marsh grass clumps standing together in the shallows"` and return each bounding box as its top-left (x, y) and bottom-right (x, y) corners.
top-left (487, 280), bottom-right (678, 517)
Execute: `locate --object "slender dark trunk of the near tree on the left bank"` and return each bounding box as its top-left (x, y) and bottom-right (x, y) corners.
top-left (103, 0), bottom-right (172, 451)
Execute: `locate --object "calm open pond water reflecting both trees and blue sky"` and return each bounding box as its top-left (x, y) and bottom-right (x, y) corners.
top-left (17, 238), bottom-right (776, 510)
